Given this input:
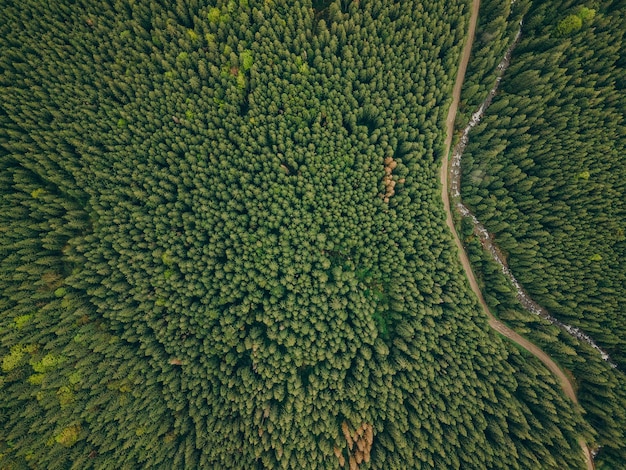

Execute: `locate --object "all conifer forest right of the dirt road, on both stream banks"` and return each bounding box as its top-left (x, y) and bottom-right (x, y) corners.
top-left (457, 1), bottom-right (626, 469)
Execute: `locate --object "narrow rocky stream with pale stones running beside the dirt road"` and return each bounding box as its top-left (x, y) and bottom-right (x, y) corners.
top-left (450, 21), bottom-right (617, 368)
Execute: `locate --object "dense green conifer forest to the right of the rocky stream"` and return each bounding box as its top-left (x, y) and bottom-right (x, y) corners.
top-left (464, 0), bottom-right (626, 363)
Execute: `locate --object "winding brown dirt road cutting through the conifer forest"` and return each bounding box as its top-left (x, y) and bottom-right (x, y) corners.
top-left (441, 0), bottom-right (595, 470)
